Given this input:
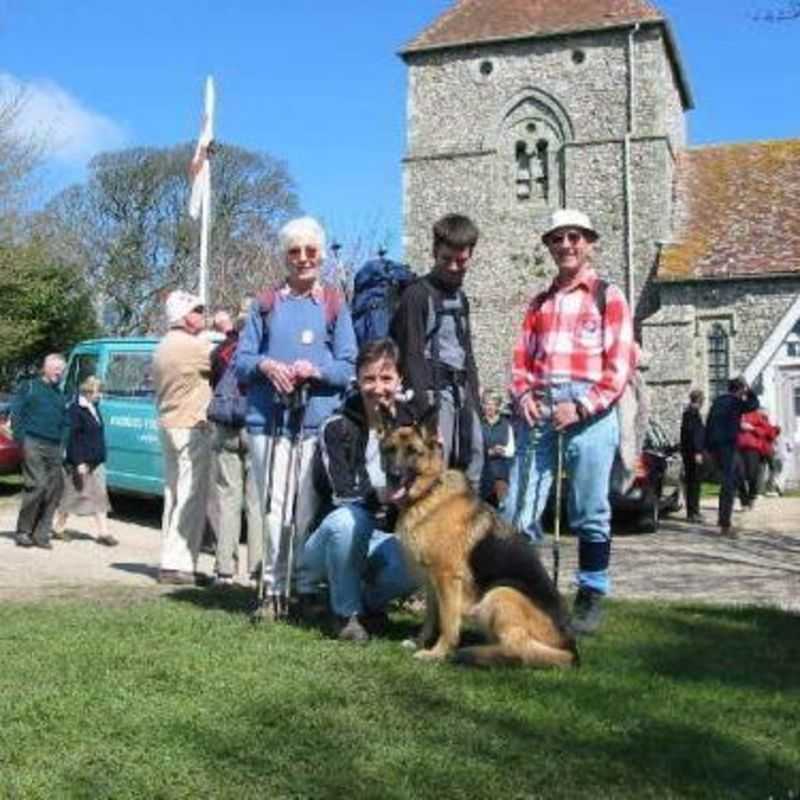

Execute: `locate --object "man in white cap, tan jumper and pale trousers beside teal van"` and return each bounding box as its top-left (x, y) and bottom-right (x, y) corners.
top-left (153, 291), bottom-right (211, 584)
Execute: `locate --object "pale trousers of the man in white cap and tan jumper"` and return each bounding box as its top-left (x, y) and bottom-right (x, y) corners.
top-left (161, 425), bottom-right (211, 572)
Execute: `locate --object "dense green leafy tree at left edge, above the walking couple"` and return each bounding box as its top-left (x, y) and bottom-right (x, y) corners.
top-left (0, 241), bottom-right (97, 388)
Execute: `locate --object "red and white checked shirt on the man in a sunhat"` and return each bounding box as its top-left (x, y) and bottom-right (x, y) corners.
top-left (510, 268), bottom-right (635, 414)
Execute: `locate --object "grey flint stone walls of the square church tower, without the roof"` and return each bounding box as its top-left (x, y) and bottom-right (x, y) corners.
top-left (404, 21), bottom-right (686, 388)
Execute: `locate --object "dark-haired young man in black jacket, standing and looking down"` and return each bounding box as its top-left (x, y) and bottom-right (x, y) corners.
top-left (390, 214), bottom-right (483, 492)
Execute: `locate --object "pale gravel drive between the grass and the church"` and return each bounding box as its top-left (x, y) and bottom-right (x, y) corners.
top-left (0, 488), bottom-right (800, 612)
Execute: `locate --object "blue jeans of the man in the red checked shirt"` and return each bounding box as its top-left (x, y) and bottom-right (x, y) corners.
top-left (503, 409), bottom-right (619, 594)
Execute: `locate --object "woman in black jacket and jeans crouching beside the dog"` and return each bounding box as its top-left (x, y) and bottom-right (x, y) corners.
top-left (298, 339), bottom-right (418, 642)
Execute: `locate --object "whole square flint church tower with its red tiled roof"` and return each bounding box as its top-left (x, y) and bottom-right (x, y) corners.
top-left (401, 0), bottom-right (692, 386)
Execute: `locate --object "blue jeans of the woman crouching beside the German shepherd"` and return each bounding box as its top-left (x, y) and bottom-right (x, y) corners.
top-left (298, 504), bottom-right (418, 617)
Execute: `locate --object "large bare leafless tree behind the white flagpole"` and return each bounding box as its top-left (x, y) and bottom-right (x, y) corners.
top-left (36, 143), bottom-right (297, 335)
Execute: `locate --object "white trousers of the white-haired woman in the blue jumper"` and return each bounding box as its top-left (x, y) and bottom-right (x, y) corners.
top-left (249, 433), bottom-right (320, 595)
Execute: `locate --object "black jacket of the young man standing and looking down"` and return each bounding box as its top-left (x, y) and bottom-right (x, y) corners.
top-left (390, 275), bottom-right (480, 416)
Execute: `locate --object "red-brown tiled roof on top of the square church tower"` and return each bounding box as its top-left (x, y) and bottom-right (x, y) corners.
top-left (403, 0), bottom-right (664, 54)
